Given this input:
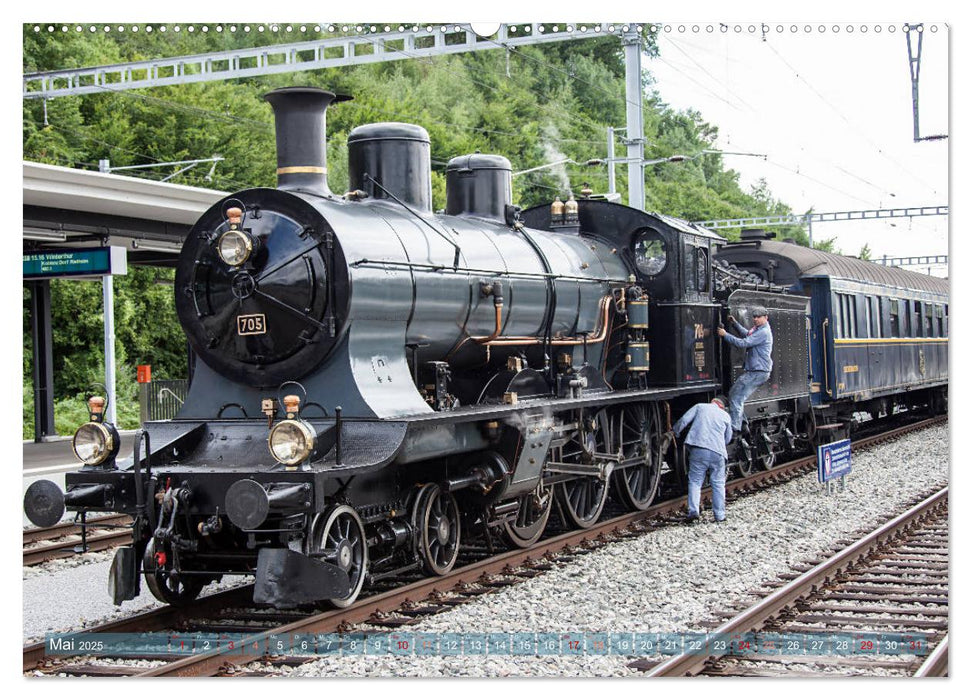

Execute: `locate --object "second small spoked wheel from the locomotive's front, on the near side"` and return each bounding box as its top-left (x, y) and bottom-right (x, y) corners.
top-left (415, 484), bottom-right (462, 576)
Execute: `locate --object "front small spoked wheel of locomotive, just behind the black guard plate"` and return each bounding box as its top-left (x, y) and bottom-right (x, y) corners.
top-left (307, 505), bottom-right (368, 608)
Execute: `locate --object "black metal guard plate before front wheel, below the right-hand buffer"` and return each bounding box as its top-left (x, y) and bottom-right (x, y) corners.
top-left (253, 549), bottom-right (351, 608)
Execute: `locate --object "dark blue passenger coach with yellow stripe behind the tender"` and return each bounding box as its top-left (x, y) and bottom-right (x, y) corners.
top-left (718, 232), bottom-right (949, 419)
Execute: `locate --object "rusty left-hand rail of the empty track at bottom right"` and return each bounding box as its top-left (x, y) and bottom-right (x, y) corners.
top-left (647, 486), bottom-right (948, 677)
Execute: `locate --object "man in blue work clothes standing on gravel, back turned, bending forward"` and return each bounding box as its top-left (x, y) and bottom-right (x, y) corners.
top-left (671, 396), bottom-right (732, 523)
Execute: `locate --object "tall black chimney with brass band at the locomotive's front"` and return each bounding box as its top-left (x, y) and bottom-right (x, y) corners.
top-left (263, 87), bottom-right (352, 196)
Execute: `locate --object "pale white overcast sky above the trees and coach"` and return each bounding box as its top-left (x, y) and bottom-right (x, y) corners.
top-left (646, 17), bottom-right (948, 274)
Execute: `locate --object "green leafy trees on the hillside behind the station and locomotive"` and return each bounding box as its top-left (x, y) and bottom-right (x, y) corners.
top-left (23, 25), bottom-right (806, 434)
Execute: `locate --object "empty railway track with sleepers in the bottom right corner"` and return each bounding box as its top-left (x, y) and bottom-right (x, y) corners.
top-left (634, 487), bottom-right (948, 677)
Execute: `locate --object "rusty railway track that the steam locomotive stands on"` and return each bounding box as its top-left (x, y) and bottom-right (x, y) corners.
top-left (24, 418), bottom-right (945, 677)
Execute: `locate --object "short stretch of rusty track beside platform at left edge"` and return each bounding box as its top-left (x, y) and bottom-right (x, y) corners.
top-left (23, 515), bottom-right (131, 566)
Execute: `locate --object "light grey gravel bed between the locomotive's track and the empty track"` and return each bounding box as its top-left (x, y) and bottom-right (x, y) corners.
top-left (280, 425), bottom-right (949, 677)
